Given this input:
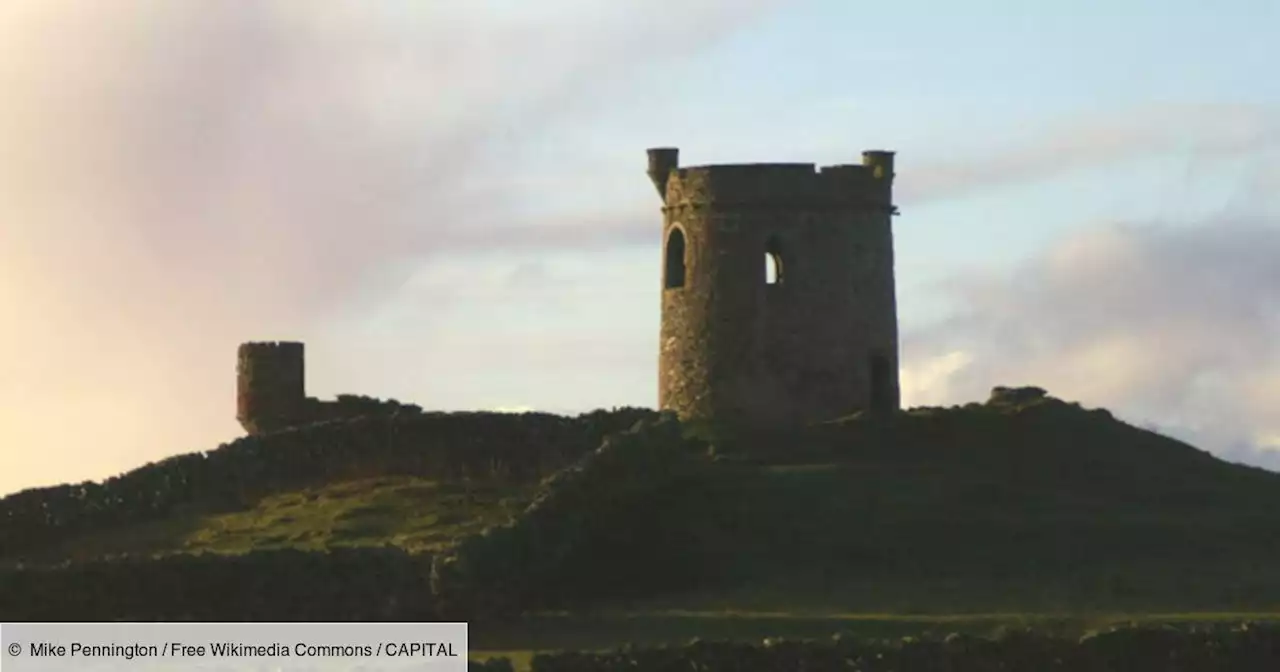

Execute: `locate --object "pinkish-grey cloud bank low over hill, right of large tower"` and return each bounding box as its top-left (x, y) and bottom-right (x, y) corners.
top-left (902, 219), bottom-right (1280, 466)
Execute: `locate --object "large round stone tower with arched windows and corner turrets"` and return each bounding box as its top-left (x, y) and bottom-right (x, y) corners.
top-left (649, 148), bottom-right (899, 424)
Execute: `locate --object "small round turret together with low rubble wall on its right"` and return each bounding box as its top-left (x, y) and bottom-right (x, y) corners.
top-left (236, 342), bottom-right (421, 435)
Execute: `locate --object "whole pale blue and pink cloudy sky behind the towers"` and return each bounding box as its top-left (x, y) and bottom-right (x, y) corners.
top-left (0, 0), bottom-right (1280, 494)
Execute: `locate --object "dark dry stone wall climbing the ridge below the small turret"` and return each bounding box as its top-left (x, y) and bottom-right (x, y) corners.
top-left (0, 408), bottom-right (657, 561)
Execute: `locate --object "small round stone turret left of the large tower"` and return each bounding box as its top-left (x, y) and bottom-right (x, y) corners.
top-left (236, 340), bottom-right (306, 434)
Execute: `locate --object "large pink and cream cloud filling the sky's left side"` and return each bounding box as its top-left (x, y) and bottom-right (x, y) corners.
top-left (0, 0), bottom-right (773, 492)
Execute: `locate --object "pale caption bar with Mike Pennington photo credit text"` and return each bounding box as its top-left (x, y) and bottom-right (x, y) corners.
top-left (0, 623), bottom-right (467, 672)
